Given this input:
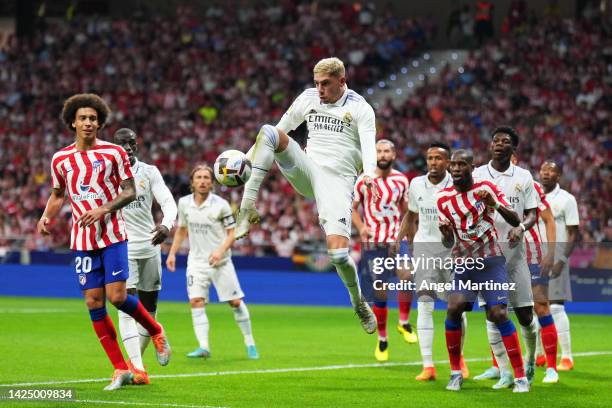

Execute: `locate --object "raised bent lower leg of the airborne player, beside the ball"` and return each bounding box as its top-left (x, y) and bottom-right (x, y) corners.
top-left (236, 125), bottom-right (286, 239)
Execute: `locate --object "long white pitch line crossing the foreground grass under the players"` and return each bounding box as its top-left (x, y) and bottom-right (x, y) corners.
top-left (0, 351), bottom-right (612, 387)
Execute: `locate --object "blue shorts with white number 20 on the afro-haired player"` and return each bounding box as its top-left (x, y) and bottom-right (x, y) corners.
top-left (74, 241), bottom-right (129, 290)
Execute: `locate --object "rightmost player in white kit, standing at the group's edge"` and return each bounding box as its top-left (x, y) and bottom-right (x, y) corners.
top-left (540, 160), bottom-right (580, 371)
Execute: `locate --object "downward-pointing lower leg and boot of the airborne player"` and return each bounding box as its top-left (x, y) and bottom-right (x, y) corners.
top-left (327, 248), bottom-right (376, 334)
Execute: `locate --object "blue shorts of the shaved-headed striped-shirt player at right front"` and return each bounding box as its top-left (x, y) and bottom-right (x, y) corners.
top-left (450, 256), bottom-right (510, 306)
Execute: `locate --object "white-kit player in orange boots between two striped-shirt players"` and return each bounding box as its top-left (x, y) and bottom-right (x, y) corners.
top-left (398, 142), bottom-right (469, 381)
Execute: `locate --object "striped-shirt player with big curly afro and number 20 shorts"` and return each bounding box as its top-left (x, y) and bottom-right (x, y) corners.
top-left (37, 94), bottom-right (171, 390)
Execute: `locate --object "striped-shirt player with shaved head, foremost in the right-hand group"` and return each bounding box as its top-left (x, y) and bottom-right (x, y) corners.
top-left (437, 150), bottom-right (529, 392)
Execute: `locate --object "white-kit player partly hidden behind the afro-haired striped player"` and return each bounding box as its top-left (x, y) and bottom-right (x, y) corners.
top-left (113, 128), bottom-right (177, 384)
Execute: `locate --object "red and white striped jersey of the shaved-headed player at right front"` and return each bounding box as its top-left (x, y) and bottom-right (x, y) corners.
top-left (438, 180), bottom-right (509, 258)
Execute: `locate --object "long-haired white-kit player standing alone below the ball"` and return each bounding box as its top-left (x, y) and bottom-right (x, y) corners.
top-left (166, 165), bottom-right (259, 360)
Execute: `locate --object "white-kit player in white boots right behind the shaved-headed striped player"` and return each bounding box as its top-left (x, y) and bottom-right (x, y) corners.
top-left (474, 126), bottom-right (538, 389)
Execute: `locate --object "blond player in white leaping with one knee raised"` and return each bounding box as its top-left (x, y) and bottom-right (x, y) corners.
top-left (236, 58), bottom-right (378, 333)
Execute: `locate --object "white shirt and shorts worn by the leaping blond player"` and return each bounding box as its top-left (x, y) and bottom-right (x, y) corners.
top-left (276, 87), bottom-right (376, 238)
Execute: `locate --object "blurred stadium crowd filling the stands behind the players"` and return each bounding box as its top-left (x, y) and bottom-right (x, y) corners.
top-left (0, 1), bottom-right (612, 256)
